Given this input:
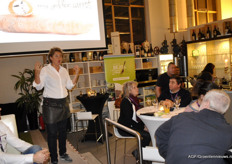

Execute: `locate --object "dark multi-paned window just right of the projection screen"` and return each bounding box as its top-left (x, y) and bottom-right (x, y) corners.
top-left (104, 0), bottom-right (146, 44)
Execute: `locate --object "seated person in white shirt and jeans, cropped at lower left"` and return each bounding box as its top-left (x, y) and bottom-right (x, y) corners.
top-left (0, 108), bottom-right (50, 164)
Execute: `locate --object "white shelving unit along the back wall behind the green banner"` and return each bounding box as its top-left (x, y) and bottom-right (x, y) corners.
top-left (63, 56), bottom-right (159, 109)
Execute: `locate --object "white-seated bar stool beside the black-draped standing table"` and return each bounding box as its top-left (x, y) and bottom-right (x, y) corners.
top-left (76, 112), bottom-right (103, 149)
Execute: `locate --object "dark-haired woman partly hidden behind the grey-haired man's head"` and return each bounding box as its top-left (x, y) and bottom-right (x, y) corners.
top-left (185, 80), bottom-right (219, 112)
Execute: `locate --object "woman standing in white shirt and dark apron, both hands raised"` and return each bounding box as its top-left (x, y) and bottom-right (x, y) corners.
top-left (33, 47), bottom-right (80, 164)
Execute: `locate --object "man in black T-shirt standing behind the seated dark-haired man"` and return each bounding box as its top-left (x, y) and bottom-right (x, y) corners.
top-left (155, 62), bottom-right (176, 97)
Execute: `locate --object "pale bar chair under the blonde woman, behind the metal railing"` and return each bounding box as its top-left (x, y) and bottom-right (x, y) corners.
top-left (113, 126), bottom-right (135, 164)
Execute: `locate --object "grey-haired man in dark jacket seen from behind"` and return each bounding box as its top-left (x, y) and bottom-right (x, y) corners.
top-left (155, 89), bottom-right (232, 164)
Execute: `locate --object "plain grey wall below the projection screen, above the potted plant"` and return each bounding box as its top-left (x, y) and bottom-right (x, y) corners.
top-left (0, 56), bottom-right (43, 104)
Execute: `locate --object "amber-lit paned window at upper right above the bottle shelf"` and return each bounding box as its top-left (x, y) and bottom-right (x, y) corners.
top-left (194, 0), bottom-right (218, 25)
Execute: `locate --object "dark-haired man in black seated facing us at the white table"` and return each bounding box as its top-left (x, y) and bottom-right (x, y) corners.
top-left (158, 76), bottom-right (191, 107)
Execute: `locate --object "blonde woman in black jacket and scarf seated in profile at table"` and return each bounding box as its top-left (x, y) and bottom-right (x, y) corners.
top-left (118, 81), bottom-right (151, 159)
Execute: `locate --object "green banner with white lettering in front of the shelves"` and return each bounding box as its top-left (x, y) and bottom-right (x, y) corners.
top-left (104, 55), bottom-right (136, 84)
